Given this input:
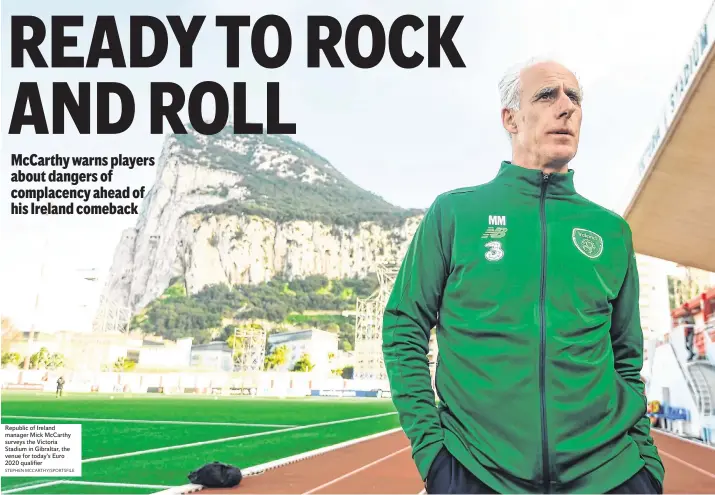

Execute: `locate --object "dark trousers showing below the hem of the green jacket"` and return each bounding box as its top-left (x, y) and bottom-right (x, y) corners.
top-left (425, 448), bottom-right (663, 495)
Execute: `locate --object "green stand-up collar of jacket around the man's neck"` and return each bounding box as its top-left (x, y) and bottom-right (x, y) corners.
top-left (492, 161), bottom-right (576, 198)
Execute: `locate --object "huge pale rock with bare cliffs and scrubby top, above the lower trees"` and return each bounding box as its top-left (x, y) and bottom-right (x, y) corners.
top-left (104, 128), bottom-right (421, 312)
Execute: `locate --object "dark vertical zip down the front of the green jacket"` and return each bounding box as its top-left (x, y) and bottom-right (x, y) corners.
top-left (539, 174), bottom-right (551, 493)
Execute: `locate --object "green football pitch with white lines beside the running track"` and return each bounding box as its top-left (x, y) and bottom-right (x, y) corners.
top-left (0, 392), bottom-right (399, 495)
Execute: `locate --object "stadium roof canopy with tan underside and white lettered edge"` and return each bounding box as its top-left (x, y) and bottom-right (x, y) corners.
top-left (623, 4), bottom-right (715, 272)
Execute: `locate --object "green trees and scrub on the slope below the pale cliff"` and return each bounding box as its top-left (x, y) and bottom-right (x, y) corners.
top-left (131, 275), bottom-right (378, 350)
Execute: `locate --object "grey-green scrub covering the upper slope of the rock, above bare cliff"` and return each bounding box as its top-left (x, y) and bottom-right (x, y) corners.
top-left (176, 127), bottom-right (423, 228)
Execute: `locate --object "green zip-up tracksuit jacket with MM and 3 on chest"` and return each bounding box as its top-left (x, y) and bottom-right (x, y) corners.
top-left (383, 162), bottom-right (664, 493)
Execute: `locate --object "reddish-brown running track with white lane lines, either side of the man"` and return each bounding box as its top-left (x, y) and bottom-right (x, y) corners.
top-left (199, 430), bottom-right (715, 495)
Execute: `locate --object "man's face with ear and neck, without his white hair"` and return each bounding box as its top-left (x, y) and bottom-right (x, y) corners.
top-left (504, 62), bottom-right (581, 167)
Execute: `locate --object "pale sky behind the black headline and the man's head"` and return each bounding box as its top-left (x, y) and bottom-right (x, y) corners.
top-left (0, 0), bottom-right (712, 330)
